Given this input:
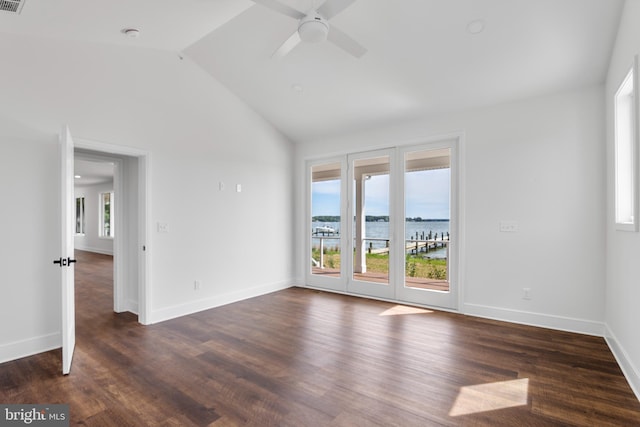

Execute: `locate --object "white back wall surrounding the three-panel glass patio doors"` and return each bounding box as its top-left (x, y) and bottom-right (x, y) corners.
top-left (296, 87), bottom-right (605, 334)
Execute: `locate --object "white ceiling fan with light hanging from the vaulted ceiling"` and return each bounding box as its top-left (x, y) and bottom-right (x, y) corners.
top-left (253, 0), bottom-right (367, 58)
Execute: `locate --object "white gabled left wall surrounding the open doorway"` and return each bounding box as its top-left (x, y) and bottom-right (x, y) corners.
top-left (0, 35), bottom-right (293, 360)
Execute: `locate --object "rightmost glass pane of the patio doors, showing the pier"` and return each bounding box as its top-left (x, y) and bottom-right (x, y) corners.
top-left (404, 148), bottom-right (455, 292)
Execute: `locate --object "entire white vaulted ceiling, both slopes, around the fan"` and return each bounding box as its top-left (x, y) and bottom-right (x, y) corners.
top-left (0, 0), bottom-right (624, 142)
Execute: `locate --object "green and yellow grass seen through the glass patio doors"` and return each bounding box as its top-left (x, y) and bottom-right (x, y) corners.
top-left (311, 248), bottom-right (447, 280)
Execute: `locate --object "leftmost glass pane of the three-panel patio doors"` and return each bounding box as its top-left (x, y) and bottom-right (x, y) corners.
top-left (310, 162), bottom-right (342, 279)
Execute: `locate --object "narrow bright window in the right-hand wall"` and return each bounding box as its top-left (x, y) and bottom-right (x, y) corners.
top-left (614, 58), bottom-right (638, 231)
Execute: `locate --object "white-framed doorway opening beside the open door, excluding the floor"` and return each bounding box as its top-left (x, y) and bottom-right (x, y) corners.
top-left (74, 139), bottom-right (149, 324)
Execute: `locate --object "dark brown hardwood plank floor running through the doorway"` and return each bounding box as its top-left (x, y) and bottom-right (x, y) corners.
top-left (0, 252), bottom-right (640, 427)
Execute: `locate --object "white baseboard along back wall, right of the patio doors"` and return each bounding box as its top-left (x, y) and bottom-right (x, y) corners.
top-left (463, 304), bottom-right (604, 337)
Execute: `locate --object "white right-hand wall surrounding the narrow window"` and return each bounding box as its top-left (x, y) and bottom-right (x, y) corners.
top-left (606, 0), bottom-right (640, 397)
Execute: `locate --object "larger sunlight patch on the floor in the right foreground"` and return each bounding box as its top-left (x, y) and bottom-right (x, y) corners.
top-left (449, 378), bottom-right (529, 417)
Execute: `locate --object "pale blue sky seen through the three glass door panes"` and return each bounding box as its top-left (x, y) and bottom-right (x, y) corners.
top-left (311, 169), bottom-right (450, 219)
